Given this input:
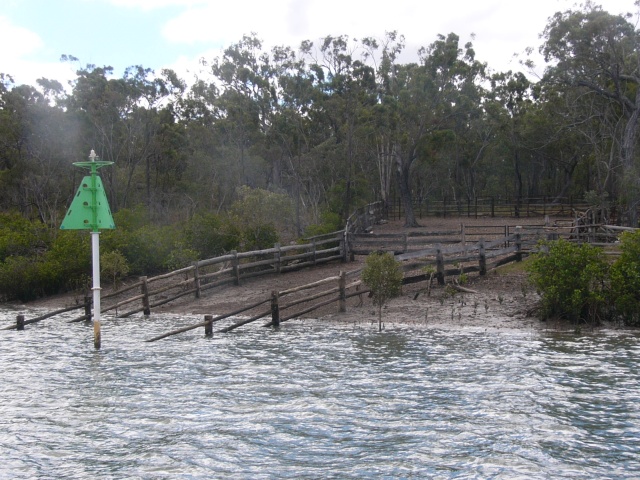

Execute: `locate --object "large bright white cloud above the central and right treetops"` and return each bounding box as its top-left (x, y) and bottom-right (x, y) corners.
top-left (156, 0), bottom-right (559, 74)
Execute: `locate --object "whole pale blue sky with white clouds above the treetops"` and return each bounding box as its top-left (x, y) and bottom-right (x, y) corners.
top-left (0, 0), bottom-right (638, 86)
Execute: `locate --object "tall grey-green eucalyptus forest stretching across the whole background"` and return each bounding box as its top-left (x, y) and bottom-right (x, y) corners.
top-left (0, 3), bottom-right (640, 233)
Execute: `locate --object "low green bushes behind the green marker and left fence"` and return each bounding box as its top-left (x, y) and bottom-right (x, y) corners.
top-left (0, 188), bottom-right (304, 301)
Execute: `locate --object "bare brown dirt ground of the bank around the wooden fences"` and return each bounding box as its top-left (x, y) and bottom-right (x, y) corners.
top-left (20, 217), bottom-right (560, 330)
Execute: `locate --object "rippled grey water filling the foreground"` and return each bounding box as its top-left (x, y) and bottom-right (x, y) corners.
top-left (0, 310), bottom-right (640, 479)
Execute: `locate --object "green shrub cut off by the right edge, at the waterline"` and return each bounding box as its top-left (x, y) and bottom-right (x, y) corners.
top-left (610, 230), bottom-right (640, 326)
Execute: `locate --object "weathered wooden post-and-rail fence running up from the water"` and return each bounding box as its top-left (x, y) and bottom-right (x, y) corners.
top-left (4, 208), bottom-right (635, 341)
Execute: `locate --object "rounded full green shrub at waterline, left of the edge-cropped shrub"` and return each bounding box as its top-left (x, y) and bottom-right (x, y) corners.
top-left (527, 240), bottom-right (609, 322)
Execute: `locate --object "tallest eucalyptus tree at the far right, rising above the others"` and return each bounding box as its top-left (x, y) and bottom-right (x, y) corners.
top-left (540, 2), bottom-right (640, 226)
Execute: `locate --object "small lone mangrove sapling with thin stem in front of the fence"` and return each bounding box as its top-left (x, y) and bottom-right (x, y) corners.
top-left (361, 252), bottom-right (403, 330)
